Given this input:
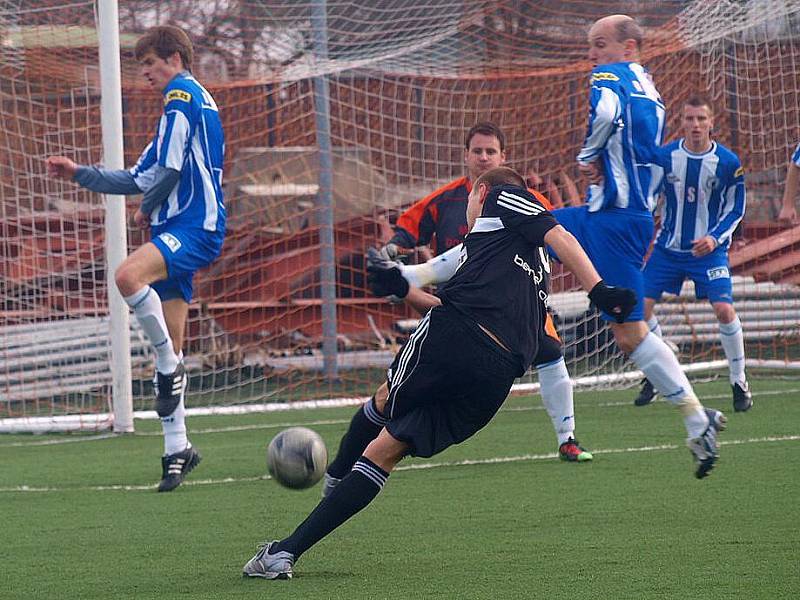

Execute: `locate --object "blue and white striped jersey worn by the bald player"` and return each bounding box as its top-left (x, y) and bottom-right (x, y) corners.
top-left (578, 62), bottom-right (665, 212)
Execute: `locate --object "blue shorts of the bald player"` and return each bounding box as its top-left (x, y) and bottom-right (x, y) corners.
top-left (550, 206), bottom-right (653, 322)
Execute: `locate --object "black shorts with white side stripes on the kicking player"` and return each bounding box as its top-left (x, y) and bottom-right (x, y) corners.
top-left (384, 306), bottom-right (519, 457)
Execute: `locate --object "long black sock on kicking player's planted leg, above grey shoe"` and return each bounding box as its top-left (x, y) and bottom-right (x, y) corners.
top-left (270, 456), bottom-right (389, 558)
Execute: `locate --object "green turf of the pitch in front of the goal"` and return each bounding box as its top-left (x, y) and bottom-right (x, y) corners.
top-left (0, 379), bottom-right (800, 600)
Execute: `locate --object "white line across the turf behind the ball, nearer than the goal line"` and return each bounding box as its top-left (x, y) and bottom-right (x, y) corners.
top-left (0, 435), bottom-right (800, 493)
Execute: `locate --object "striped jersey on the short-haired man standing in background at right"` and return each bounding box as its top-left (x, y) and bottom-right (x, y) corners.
top-left (656, 139), bottom-right (745, 252)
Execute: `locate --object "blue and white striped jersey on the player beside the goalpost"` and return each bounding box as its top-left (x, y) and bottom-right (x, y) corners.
top-left (130, 71), bottom-right (225, 233)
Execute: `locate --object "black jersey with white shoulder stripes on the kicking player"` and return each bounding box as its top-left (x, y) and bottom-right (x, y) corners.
top-left (438, 186), bottom-right (558, 375)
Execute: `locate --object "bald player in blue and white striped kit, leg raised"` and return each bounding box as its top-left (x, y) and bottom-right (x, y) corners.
top-left (553, 15), bottom-right (726, 479)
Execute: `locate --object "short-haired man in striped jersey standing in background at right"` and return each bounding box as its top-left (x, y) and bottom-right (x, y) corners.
top-left (634, 96), bottom-right (753, 412)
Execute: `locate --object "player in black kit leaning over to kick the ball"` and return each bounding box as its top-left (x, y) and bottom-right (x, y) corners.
top-left (243, 167), bottom-right (636, 579)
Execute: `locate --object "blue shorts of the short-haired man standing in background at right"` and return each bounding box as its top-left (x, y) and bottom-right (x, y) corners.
top-left (644, 246), bottom-right (733, 304)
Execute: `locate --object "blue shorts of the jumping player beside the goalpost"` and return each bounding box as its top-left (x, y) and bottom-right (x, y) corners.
top-left (150, 227), bottom-right (225, 303)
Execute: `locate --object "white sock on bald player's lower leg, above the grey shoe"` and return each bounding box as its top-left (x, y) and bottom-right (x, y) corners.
top-left (631, 333), bottom-right (708, 438)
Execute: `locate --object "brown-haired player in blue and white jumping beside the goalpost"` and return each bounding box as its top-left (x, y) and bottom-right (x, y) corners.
top-left (47, 25), bottom-right (225, 492)
